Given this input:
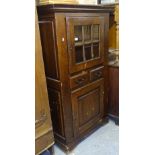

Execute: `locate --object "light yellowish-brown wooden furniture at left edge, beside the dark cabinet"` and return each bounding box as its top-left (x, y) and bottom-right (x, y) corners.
top-left (35, 9), bottom-right (54, 155)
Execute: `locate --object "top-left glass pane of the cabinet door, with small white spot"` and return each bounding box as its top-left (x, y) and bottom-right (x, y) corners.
top-left (74, 25), bottom-right (82, 42)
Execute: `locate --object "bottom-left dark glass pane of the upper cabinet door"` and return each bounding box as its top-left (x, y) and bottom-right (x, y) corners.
top-left (75, 46), bottom-right (83, 63)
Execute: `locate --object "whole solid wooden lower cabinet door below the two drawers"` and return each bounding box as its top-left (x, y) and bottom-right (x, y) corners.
top-left (72, 80), bottom-right (104, 137)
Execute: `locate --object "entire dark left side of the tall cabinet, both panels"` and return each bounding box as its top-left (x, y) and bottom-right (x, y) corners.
top-left (39, 13), bottom-right (66, 142)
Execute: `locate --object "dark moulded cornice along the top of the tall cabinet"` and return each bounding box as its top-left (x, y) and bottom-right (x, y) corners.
top-left (37, 4), bottom-right (114, 15)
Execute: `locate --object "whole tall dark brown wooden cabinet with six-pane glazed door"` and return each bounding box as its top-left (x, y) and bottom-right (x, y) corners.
top-left (38, 4), bottom-right (110, 150)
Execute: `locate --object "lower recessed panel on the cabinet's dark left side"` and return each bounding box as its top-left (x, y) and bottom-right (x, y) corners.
top-left (48, 88), bottom-right (65, 139)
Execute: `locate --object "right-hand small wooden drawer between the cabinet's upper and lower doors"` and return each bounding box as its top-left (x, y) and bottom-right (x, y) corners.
top-left (90, 66), bottom-right (104, 81)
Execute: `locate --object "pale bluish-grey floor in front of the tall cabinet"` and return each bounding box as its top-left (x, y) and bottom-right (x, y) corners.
top-left (54, 121), bottom-right (119, 155)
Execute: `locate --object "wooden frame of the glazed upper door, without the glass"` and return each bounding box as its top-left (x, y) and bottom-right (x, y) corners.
top-left (66, 14), bottom-right (105, 74)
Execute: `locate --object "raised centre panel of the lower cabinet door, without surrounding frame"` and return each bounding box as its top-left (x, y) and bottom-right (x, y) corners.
top-left (78, 89), bottom-right (100, 128)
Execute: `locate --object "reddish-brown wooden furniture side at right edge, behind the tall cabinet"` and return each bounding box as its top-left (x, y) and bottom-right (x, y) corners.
top-left (108, 66), bottom-right (119, 124)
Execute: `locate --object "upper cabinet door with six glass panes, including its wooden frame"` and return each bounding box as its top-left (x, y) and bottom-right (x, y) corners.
top-left (66, 16), bottom-right (104, 73)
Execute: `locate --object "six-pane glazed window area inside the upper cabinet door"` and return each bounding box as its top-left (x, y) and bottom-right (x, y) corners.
top-left (74, 24), bottom-right (100, 63)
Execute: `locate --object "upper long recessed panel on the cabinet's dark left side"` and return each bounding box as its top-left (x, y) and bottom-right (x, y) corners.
top-left (39, 21), bottom-right (59, 79)
